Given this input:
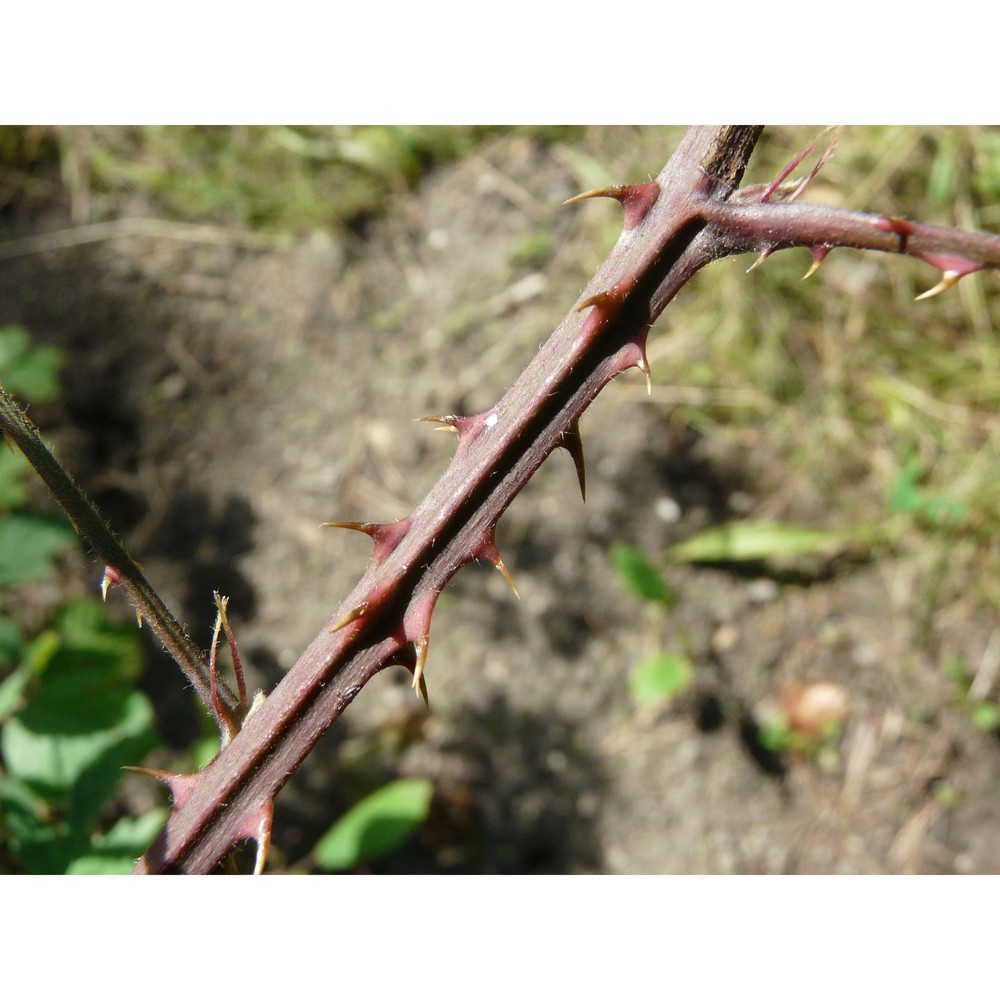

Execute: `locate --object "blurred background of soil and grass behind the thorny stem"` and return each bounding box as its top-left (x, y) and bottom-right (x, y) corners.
top-left (0, 127), bottom-right (1000, 873)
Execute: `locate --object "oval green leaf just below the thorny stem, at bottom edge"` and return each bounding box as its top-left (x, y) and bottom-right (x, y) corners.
top-left (315, 778), bottom-right (434, 871)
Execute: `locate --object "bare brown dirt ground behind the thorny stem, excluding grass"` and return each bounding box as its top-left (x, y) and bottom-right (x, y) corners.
top-left (0, 131), bottom-right (1000, 873)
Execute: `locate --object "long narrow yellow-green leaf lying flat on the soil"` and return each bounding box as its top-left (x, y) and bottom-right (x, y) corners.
top-left (667, 521), bottom-right (877, 563)
